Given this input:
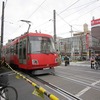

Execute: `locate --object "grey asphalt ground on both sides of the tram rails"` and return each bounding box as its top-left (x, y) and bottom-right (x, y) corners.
top-left (0, 62), bottom-right (100, 100)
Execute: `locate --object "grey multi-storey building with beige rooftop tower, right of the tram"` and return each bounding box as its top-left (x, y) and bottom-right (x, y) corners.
top-left (58, 24), bottom-right (92, 60)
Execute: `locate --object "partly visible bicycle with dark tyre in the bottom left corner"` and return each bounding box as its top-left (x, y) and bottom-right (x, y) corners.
top-left (0, 75), bottom-right (18, 100)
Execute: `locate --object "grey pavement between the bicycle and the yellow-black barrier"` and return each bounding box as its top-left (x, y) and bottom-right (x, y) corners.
top-left (0, 68), bottom-right (50, 100)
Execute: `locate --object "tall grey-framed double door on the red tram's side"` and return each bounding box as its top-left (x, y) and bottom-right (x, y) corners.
top-left (18, 38), bottom-right (27, 64)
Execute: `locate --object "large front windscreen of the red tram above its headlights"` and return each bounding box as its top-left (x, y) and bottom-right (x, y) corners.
top-left (29, 36), bottom-right (56, 53)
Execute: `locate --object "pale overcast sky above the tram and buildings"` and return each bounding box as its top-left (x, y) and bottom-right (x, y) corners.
top-left (0, 0), bottom-right (100, 43)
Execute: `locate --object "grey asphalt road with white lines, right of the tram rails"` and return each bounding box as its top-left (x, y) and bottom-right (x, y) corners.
top-left (37, 62), bottom-right (100, 100)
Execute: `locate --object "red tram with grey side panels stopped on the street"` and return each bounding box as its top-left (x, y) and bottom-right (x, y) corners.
top-left (2, 32), bottom-right (59, 74)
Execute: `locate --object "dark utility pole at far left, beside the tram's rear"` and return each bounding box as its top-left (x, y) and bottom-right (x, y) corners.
top-left (0, 1), bottom-right (4, 59)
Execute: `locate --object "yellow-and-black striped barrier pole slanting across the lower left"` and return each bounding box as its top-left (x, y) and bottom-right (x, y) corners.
top-left (1, 61), bottom-right (59, 100)
